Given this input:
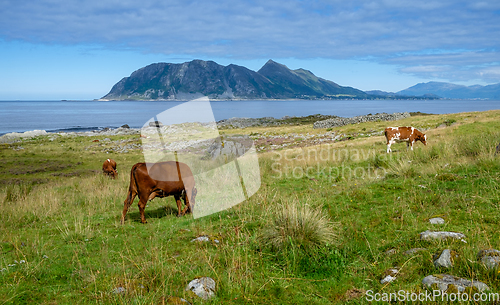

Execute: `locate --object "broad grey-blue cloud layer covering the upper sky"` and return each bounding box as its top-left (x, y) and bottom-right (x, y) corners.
top-left (0, 0), bottom-right (500, 82)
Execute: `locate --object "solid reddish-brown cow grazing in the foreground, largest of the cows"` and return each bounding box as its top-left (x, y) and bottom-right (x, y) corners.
top-left (121, 161), bottom-right (197, 224)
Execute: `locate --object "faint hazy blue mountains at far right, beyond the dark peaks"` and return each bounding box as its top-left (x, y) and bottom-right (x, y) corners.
top-left (397, 82), bottom-right (500, 99)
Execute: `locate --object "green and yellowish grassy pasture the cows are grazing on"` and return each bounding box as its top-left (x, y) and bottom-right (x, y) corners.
top-left (0, 111), bottom-right (500, 304)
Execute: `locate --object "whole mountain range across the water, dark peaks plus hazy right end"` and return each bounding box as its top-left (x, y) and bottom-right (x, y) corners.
top-left (101, 60), bottom-right (500, 100)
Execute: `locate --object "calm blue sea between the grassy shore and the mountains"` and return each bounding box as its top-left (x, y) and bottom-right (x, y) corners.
top-left (0, 100), bottom-right (500, 135)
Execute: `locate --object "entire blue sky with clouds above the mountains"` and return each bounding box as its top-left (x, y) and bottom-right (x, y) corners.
top-left (0, 0), bottom-right (500, 100)
